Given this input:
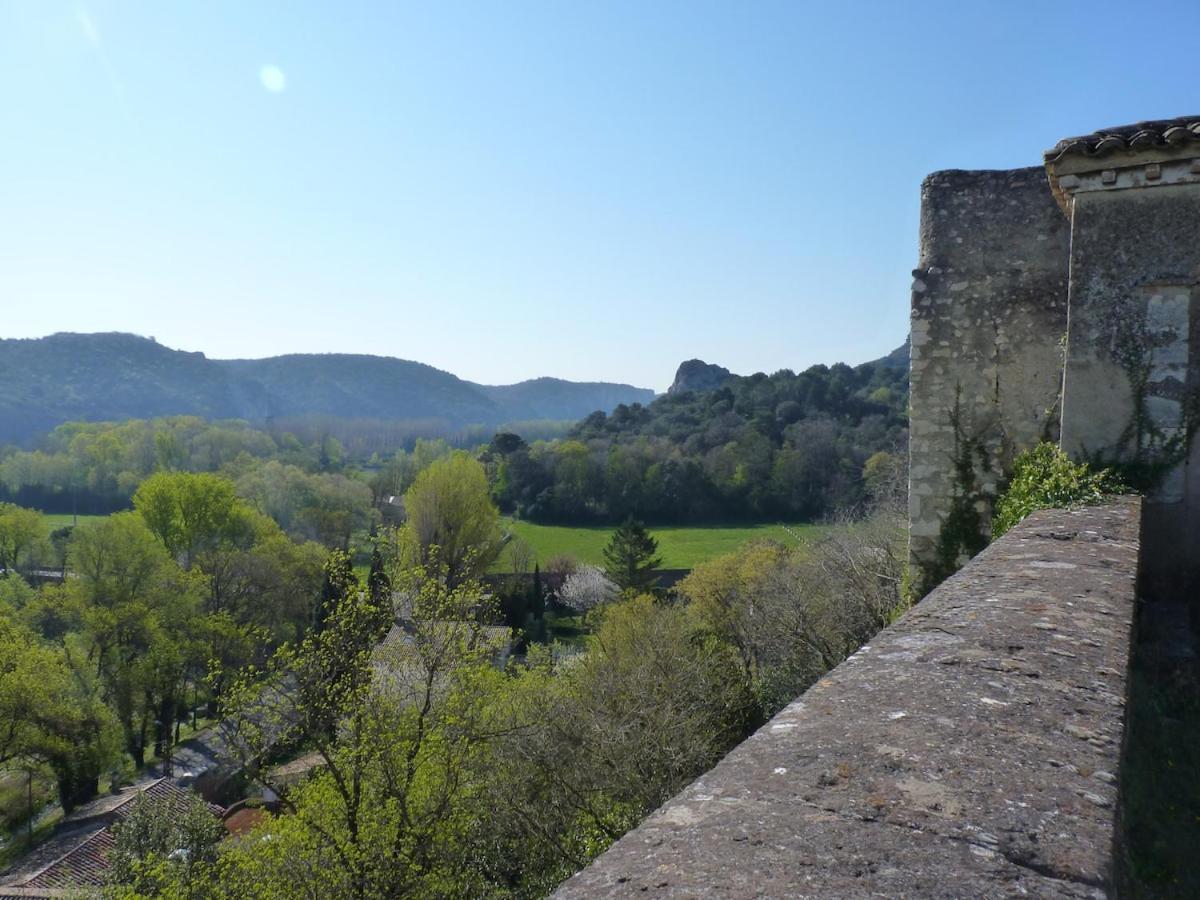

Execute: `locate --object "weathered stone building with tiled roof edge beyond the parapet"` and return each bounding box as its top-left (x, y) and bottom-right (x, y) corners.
top-left (910, 115), bottom-right (1200, 588)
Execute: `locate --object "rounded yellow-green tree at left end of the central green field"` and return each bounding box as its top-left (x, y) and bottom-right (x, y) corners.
top-left (404, 451), bottom-right (503, 587)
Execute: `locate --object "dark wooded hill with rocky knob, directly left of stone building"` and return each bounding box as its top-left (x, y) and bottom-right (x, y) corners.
top-left (486, 348), bottom-right (908, 523)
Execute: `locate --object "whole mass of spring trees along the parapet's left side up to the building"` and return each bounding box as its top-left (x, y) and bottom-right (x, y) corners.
top-left (167, 501), bottom-right (902, 898)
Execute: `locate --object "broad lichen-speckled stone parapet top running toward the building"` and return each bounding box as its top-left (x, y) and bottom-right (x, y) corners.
top-left (556, 498), bottom-right (1140, 900)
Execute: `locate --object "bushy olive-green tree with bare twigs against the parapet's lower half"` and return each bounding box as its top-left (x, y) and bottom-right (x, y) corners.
top-left (473, 595), bottom-right (751, 896)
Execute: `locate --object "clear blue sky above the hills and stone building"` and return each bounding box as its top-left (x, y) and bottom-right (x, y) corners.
top-left (0, 0), bottom-right (1200, 390)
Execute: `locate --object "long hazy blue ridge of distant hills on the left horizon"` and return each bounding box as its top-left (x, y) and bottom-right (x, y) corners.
top-left (0, 332), bottom-right (655, 442)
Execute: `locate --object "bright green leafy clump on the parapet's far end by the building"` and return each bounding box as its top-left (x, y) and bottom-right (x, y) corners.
top-left (991, 443), bottom-right (1126, 538)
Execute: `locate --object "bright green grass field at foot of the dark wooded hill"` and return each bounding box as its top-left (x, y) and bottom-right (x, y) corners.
top-left (503, 518), bottom-right (822, 569)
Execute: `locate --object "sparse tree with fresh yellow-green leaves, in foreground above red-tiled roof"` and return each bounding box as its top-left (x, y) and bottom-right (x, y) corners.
top-left (212, 572), bottom-right (504, 898)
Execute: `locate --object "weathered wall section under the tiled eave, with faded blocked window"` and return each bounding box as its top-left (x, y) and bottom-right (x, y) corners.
top-left (1062, 184), bottom-right (1200, 563)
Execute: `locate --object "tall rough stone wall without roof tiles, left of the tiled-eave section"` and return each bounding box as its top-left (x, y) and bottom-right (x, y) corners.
top-left (908, 167), bottom-right (1070, 595)
